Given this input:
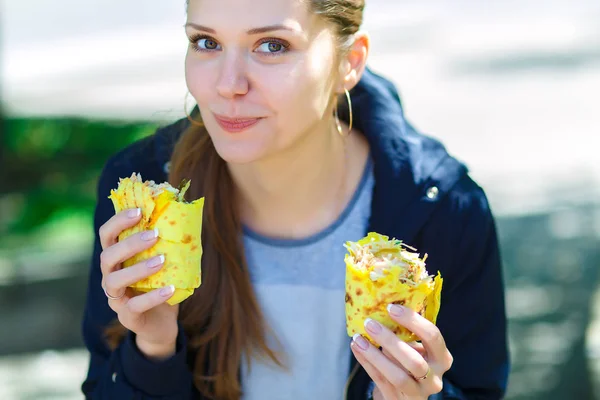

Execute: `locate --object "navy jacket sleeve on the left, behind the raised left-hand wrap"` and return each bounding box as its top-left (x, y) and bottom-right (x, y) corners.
top-left (81, 153), bottom-right (193, 400)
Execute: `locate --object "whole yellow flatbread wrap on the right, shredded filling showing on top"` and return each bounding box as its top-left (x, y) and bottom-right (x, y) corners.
top-left (344, 232), bottom-right (443, 346)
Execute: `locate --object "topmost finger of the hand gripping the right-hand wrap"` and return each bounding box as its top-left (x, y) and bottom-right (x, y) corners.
top-left (388, 304), bottom-right (452, 372)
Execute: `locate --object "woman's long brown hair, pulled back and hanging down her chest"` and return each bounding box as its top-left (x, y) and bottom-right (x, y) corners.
top-left (106, 0), bottom-right (364, 400)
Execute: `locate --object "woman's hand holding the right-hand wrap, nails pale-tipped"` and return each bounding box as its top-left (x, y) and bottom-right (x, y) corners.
top-left (351, 305), bottom-right (452, 400)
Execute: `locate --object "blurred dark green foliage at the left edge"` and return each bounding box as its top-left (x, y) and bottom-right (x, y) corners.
top-left (0, 119), bottom-right (157, 247)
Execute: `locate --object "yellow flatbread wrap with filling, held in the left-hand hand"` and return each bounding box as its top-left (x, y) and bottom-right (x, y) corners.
top-left (109, 173), bottom-right (204, 305)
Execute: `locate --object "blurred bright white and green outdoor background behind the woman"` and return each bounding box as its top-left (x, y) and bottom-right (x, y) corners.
top-left (0, 0), bottom-right (600, 400)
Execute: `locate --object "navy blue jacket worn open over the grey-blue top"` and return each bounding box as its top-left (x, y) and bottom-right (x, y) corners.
top-left (82, 70), bottom-right (509, 400)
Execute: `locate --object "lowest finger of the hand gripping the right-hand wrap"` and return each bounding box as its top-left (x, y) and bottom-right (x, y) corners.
top-left (353, 335), bottom-right (421, 398)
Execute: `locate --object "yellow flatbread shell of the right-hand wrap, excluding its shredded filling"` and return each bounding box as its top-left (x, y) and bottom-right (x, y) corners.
top-left (345, 233), bottom-right (443, 346)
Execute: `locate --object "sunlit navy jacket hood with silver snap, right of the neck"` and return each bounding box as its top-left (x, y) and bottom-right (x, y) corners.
top-left (350, 69), bottom-right (467, 240)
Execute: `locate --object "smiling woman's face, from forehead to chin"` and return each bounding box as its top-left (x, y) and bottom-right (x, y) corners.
top-left (185, 0), bottom-right (337, 163)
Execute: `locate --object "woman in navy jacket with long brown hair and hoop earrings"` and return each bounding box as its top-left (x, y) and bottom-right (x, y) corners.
top-left (82, 0), bottom-right (508, 400)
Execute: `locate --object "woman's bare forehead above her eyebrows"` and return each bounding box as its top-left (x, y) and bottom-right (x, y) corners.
top-left (187, 0), bottom-right (323, 31)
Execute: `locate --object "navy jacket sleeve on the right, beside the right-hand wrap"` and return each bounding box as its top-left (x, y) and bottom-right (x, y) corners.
top-left (424, 176), bottom-right (509, 400)
